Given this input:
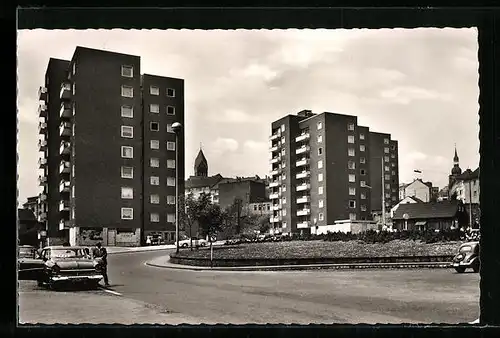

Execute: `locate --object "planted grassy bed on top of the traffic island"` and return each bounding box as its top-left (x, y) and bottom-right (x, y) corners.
top-left (177, 240), bottom-right (462, 259)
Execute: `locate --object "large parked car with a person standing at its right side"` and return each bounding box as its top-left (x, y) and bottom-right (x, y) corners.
top-left (37, 246), bottom-right (103, 288)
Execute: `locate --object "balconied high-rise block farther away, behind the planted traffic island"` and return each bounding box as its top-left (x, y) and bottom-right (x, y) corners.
top-left (269, 110), bottom-right (399, 233)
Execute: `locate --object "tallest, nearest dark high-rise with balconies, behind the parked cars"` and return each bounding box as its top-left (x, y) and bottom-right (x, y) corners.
top-left (39, 47), bottom-right (184, 245)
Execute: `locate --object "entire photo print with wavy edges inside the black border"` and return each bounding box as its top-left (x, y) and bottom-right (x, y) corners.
top-left (17, 28), bottom-right (486, 325)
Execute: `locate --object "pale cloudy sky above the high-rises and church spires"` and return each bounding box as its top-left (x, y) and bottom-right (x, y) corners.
top-left (18, 29), bottom-right (479, 203)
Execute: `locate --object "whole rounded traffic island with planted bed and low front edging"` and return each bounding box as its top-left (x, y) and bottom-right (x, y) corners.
top-left (160, 240), bottom-right (461, 271)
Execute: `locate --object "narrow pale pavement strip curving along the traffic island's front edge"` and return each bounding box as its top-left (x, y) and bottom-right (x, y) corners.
top-left (146, 256), bottom-right (451, 271)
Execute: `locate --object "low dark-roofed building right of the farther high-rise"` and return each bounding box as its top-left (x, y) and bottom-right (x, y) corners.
top-left (392, 201), bottom-right (468, 230)
